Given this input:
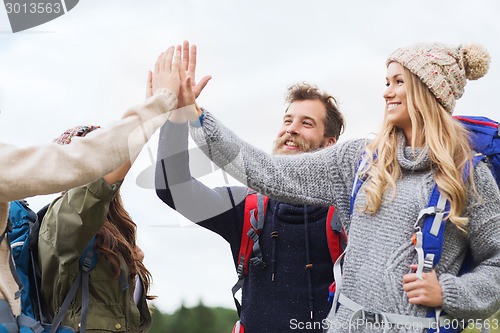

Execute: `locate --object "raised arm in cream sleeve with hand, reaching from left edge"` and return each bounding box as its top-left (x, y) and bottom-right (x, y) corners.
top-left (0, 47), bottom-right (181, 202)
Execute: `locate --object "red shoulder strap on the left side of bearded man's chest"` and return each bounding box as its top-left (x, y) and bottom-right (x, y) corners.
top-left (232, 189), bottom-right (269, 315)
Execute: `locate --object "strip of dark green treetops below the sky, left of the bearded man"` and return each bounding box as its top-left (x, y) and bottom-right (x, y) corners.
top-left (148, 302), bottom-right (238, 333)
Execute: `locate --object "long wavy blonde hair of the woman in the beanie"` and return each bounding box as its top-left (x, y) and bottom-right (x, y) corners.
top-left (363, 68), bottom-right (473, 232)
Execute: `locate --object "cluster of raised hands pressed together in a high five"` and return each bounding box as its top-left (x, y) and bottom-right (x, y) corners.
top-left (146, 41), bottom-right (211, 122)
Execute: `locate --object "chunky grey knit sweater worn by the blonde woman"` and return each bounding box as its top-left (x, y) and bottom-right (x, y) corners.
top-left (191, 111), bottom-right (500, 332)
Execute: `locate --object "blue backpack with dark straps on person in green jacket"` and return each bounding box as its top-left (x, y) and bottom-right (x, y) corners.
top-left (0, 200), bottom-right (97, 333)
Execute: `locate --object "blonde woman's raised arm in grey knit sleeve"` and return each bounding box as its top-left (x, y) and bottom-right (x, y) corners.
top-left (191, 111), bottom-right (366, 212)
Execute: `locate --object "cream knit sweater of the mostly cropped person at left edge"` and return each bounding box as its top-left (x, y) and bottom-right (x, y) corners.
top-left (0, 89), bottom-right (177, 315)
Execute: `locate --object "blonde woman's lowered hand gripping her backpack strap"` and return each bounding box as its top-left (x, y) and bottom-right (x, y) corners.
top-left (403, 265), bottom-right (443, 308)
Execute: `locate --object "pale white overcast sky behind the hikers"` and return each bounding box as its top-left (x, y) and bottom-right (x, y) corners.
top-left (0, 0), bottom-right (500, 312)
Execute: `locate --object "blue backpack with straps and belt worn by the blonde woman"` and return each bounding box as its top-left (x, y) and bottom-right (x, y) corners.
top-left (334, 116), bottom-right (500, 333)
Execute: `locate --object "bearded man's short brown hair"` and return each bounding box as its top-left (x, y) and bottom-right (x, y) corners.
top-left (285, 82), bottom-right (345, 140)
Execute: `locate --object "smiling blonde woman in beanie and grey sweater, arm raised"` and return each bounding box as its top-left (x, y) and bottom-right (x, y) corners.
top-left (185, 44), bottom-right (500, 332)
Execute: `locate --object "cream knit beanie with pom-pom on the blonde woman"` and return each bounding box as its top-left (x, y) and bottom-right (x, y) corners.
top-left (386, 43), bottom-right (490, 113)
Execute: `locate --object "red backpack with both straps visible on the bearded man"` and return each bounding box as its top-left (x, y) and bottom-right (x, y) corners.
top-left (232, 190), bottom-right (347, 333)
